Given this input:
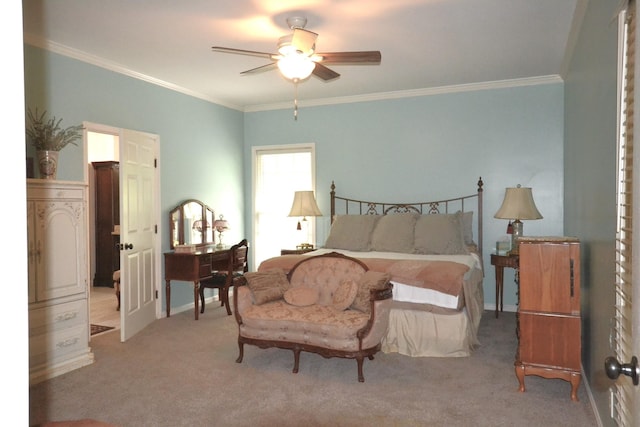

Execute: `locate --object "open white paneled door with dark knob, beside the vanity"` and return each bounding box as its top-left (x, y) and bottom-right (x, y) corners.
top-left (120, 129), bottom-right (159, 342)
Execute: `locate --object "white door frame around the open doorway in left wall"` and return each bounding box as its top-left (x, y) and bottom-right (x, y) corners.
top-left (82, 121), bottom-right (162, 340)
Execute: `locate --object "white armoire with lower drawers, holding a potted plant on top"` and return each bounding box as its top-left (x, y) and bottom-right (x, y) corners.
top-left (27, 179), bottom-right (93, 384)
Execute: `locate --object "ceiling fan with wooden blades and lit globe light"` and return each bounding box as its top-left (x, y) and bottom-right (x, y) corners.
top-left (211, 16), bottom-right (382, 83)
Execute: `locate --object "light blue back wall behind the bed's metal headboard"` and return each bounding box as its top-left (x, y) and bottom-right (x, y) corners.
top-left (244, 84), bottom-right (564, 309)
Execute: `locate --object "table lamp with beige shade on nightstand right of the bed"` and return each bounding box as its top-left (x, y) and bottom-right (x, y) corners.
top-left (493, 184), bottom-right (542, 255)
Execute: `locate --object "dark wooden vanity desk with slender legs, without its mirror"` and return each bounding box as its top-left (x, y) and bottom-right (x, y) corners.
top-left (164, 246), bottom-right (231, 320)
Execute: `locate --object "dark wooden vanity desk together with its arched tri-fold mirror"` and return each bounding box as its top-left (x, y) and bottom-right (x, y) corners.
top-left (164, 199), bottom-right (231, 320)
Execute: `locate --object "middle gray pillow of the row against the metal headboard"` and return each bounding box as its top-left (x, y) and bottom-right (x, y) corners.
top-left (371, 213), bottom-right (420, 254)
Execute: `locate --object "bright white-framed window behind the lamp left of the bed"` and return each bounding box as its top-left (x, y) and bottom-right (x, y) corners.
top-left (252, 144), bottom-right (315, 269)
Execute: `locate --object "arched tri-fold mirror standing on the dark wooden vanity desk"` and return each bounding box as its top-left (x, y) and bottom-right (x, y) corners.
top-left (169, 199), bottom-right (215, 249)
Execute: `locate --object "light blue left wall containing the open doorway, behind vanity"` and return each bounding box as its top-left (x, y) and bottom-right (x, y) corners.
top-left (25, 45), bottom-right (245, 308)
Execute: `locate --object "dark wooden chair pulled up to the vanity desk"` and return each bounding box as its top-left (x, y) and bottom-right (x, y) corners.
top-left (199, 239), bottom-right (249, 315)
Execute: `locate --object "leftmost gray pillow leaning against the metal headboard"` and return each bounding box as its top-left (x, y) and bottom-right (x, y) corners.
top-left (324, 215), bottom-right (379, 252)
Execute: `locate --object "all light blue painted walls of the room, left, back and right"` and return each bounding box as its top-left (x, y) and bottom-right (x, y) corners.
top-left (25, 1), bottom-right (618, 425)
